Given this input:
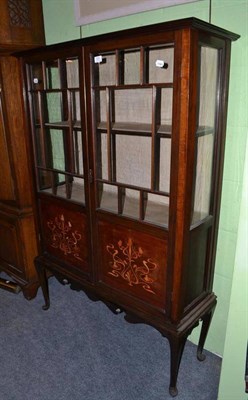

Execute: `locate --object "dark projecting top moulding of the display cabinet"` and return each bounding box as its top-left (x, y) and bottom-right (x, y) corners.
top-left (14, 17), bottom-right (240, 61)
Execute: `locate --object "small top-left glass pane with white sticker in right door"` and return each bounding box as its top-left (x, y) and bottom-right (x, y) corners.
top-left (93, 53), bottom-right (116, 86)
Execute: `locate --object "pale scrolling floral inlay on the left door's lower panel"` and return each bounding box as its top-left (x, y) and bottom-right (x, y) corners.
top-left (47, 214), bottom-right (82, 260)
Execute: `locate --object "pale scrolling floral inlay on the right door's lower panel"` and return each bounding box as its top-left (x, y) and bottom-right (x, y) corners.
top-left (106, 239), bottom-right (158, 294)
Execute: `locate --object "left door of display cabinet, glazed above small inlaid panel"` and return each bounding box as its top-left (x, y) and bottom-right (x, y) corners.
top-left (26, 51), bottom-right (91, 276)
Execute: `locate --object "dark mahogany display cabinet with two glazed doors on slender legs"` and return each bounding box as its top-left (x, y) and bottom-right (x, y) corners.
top-left (18, 18), bottom-right (238, 396)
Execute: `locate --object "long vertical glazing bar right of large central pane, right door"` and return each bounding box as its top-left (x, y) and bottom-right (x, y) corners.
top-left (151, 86), bottom-right (161, 190)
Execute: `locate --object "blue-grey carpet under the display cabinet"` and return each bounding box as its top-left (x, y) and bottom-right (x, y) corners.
top-left (0, 278), bottom-right (221, 400)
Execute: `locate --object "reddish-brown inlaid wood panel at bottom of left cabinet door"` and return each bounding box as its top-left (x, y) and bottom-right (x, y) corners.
top-left (40, 200), bottom-right (89, 272)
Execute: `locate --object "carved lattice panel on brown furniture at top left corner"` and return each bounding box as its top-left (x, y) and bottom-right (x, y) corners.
top-left (8, 0), bottom-right (31, 28)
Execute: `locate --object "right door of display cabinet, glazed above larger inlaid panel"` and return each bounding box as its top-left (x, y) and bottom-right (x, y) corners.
top-left (85, 33), bottom-right (174, 312)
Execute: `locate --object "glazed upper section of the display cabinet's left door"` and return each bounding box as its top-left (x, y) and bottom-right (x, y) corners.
top-left (27, 57), bottom-right (85, 204)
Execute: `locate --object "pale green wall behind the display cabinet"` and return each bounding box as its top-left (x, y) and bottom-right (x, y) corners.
top-left (43, 0), bottom-right (248, 360)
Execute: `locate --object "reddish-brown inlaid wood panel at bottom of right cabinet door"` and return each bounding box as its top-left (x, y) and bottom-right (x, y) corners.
top-left (98, 221), bottom-right (167, 309)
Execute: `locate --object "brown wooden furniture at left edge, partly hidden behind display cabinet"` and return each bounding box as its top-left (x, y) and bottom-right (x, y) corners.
top-left (0, 0), bottom-right (44, 298)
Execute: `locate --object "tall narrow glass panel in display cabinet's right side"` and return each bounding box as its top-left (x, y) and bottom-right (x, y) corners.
top-left (192, 46), bottom-right (219, 224)
